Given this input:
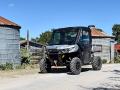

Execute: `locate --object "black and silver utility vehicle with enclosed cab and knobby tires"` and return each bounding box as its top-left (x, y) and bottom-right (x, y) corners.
top-left (39, 27), bottom-right (102, 75)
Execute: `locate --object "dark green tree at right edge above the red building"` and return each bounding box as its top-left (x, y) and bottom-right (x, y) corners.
top-left (112, 24), bottom-right (120, 43)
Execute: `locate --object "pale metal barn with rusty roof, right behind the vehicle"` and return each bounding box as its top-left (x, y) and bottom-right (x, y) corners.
top-left (92, 28), bottom-right (115, 62)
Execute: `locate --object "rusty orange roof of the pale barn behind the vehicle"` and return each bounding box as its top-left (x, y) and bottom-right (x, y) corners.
top-left (91, 28), bottom-right (114, 38)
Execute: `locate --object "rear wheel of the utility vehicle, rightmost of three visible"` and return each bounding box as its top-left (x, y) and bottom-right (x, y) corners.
top-left (92, 56), bottom-right (102, 70)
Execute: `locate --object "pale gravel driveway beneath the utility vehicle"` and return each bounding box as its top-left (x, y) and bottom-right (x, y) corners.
top-left (0, 64), bottom-right (120, 90)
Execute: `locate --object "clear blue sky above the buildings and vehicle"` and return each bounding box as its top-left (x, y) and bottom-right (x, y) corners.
top-left (0, 0), bottom-right (120, 38)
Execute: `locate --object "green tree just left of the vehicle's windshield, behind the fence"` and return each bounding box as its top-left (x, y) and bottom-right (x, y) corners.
top-left (36, 31), bottom-right (52, 44)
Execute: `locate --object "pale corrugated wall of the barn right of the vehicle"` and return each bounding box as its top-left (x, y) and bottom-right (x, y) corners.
top-left (92, 38), bottom-right (114, 62)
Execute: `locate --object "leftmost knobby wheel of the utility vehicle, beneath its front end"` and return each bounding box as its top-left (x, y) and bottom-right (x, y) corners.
top-left (39, 59), bottom-right (51, 73)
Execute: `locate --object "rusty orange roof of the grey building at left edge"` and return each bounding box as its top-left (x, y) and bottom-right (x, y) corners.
top-left (0, 16), bottom-right (21, 29)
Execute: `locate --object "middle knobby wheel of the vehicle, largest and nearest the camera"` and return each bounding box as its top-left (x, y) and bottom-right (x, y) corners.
top-left (70, 57), bottom-right (82, 75)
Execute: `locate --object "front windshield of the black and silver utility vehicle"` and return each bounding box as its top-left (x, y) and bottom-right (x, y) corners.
top-left (49, 30), bottom-right (78, 45)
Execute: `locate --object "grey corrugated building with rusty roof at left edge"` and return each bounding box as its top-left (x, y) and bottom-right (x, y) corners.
top-left (0, 16), bottom-right (21, 64)
